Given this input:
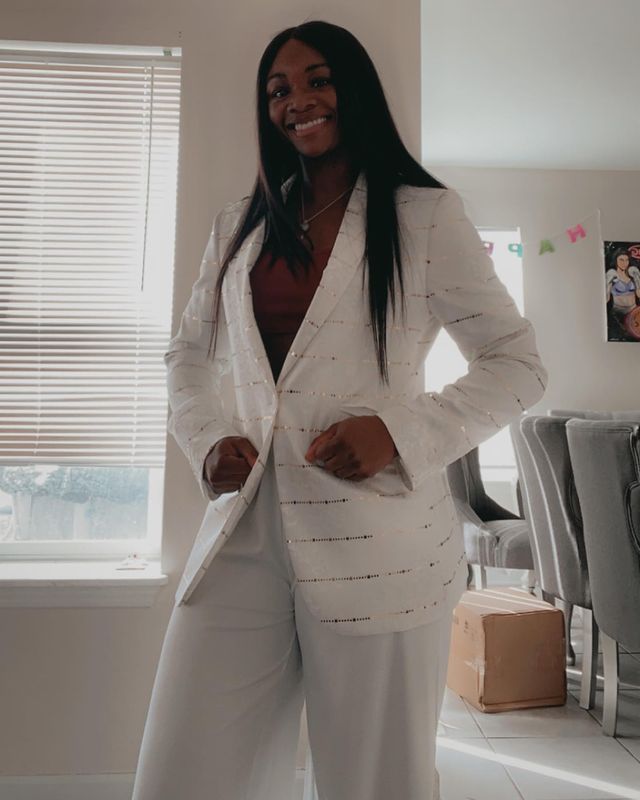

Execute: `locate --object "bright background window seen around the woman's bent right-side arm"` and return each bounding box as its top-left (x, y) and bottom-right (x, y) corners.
top-left (425, 228), bottom-right (524, 481)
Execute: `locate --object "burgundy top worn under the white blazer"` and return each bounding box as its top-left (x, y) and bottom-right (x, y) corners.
top-left (249, 248), bottom-right (331, 381)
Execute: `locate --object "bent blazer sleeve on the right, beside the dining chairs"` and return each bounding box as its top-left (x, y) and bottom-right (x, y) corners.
top-left (377, 189), bottom-right (547, 490)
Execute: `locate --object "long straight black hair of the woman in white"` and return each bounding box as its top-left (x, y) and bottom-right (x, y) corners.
top-left (210, 20), bottom-right (446, 385)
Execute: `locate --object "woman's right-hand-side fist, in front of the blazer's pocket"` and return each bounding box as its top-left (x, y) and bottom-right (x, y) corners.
top-left (305, 415), bottom-right (398, 481)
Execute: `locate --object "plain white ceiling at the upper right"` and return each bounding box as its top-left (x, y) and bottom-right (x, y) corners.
top-left (421, 0), bottom-right (640, 170)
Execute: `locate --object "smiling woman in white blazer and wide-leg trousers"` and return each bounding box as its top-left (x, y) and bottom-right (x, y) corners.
top-left (132, 21), bottom-right (546, 800)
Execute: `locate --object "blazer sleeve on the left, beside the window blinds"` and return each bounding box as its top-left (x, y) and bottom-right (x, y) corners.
top-left (163, 207), bottom-right (240, 500)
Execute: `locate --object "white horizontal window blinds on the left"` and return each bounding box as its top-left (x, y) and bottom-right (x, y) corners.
top-left (0, 45), bottom-right (180, 467)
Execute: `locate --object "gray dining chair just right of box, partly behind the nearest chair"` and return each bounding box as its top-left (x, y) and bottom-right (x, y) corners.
top-left (510, 415), bottom-right (598, 709)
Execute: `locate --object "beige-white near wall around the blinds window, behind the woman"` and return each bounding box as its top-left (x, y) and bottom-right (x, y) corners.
top-left (0, 0), bottom-right (421, 780)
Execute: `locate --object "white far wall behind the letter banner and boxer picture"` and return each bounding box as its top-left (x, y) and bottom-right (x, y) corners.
top-left (425, 164), bottom-right (640, 413)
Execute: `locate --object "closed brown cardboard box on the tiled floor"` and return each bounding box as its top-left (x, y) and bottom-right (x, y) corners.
top-left (447, 588), bottom-right (567, 712)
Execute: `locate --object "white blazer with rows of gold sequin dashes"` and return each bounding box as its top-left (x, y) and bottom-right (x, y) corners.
top-left (164, 173), bottom-right (547, 634)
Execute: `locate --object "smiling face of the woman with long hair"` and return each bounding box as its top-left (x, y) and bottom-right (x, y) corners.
top-left (267, 39), bottom-right (340, 158)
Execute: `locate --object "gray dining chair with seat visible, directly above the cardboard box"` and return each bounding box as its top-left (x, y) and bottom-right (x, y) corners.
top-left (447, 447), bottom-right (535, 591)
